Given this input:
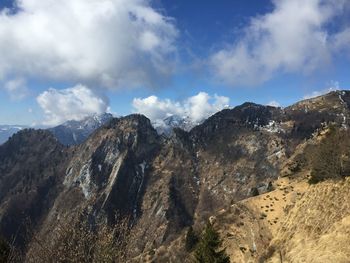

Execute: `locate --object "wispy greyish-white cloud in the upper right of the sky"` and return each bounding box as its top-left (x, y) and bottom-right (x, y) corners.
top-left (210, 0), bottom-right (350, 85)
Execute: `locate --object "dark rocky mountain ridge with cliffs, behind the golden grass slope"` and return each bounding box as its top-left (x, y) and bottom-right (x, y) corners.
top-left (0, 91), bottom-right (350, 262)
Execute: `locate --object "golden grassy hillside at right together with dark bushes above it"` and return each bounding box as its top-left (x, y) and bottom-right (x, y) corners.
top-left (205, 128), bottom-right (350, 263)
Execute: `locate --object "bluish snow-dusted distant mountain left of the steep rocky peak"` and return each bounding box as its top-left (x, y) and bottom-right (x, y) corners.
top-left (48, 113), bottom-right (113, 145)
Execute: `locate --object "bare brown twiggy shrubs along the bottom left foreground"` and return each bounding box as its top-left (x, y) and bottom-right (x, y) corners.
top-left (25, 214), bottom-right (130, 263)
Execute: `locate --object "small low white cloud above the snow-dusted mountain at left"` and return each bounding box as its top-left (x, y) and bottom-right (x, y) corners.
top-left (37, 85), bottom-right (108, 126)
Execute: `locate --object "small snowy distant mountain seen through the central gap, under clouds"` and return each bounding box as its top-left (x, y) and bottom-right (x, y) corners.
top-left (152, 115), bottom-right (200, 135)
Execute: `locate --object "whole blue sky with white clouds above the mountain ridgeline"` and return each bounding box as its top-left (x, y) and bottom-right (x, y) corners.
top-left (0, 0), bottom-right (350, 126)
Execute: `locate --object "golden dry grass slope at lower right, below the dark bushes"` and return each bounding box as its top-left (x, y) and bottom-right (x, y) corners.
top-left (208, 177), bottom-right (350, 263)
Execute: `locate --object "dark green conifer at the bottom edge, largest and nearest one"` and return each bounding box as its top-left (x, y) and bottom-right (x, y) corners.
top-left (194, 222), bottom-right (230, 263)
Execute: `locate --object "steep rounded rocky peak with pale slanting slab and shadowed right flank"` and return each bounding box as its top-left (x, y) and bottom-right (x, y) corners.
top-left (62, 114), bottom-right (159, 225)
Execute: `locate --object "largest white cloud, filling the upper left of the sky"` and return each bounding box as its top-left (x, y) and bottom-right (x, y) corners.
top-left (0, 0), bottom-right (178, 88)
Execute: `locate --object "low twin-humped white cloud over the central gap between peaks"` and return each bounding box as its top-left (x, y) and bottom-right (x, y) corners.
top-left (132, 92), bottom-right (230, 123)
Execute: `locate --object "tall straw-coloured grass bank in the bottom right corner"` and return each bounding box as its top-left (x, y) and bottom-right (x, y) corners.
top-left (269, 179), bottom-right (350, 263)
